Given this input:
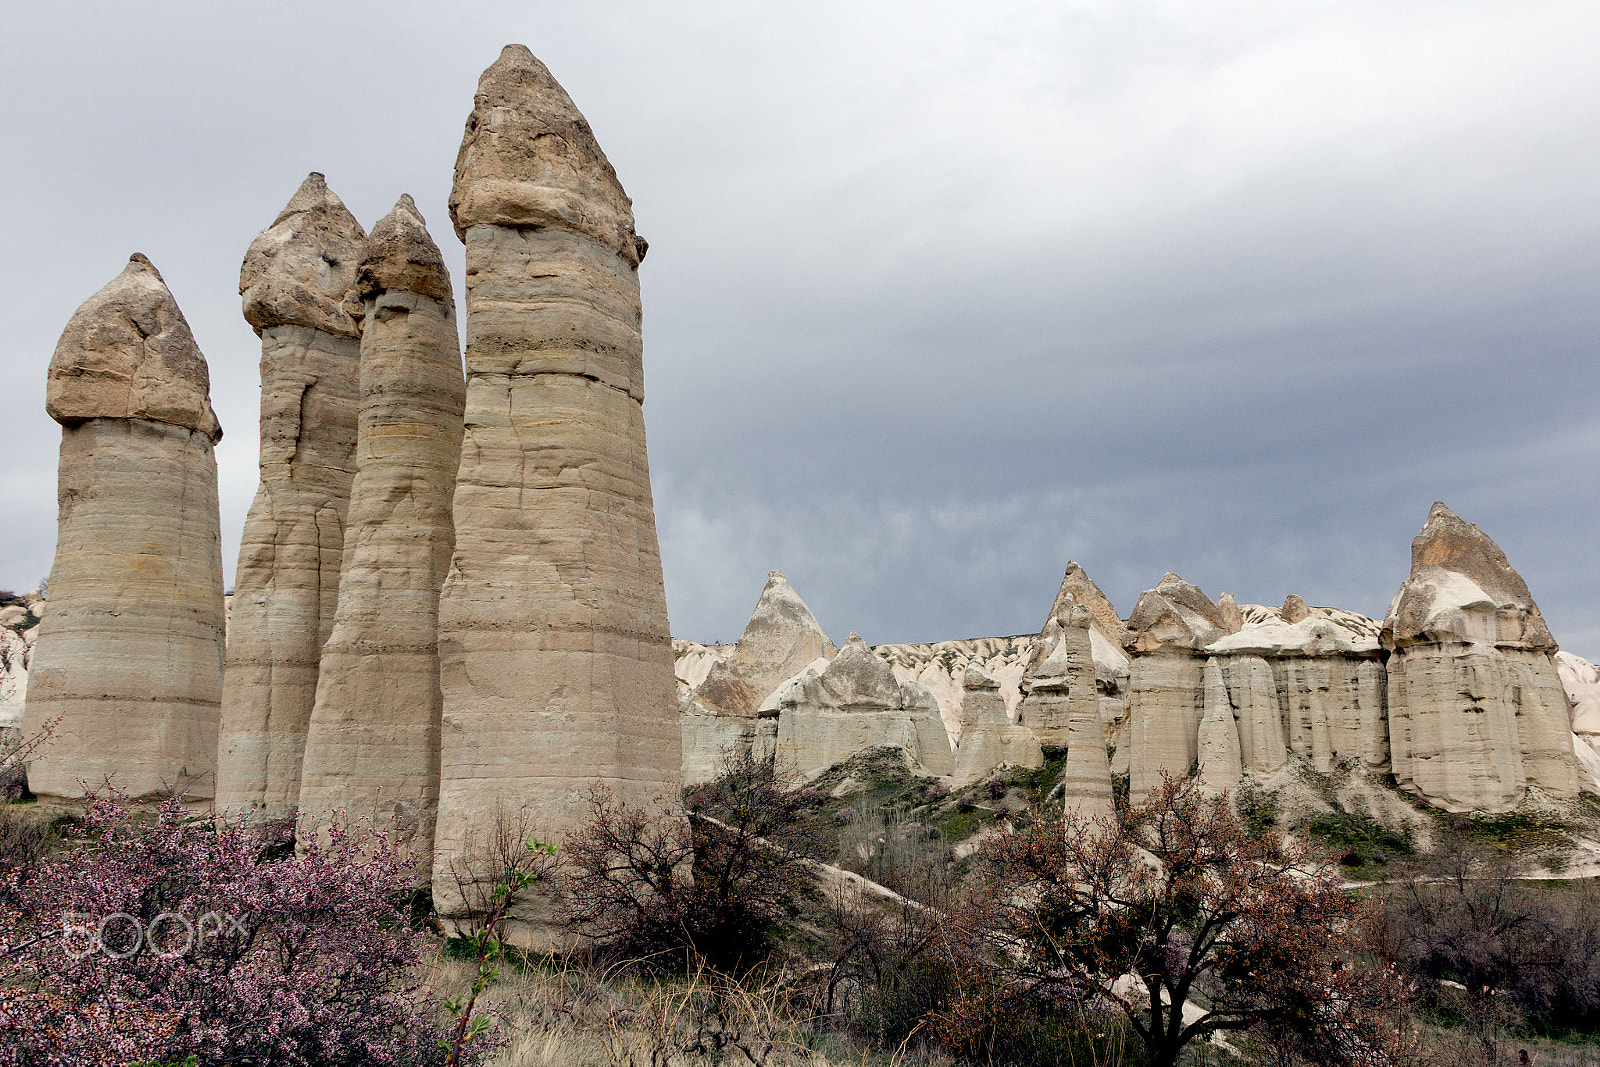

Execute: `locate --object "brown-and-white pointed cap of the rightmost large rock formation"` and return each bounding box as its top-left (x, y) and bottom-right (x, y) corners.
top-left (1382, 502), bottom-right (1557, 653)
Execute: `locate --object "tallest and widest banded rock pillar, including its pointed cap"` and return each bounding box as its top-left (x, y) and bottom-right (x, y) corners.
top-left (434, 45), bottom-right (682, 912)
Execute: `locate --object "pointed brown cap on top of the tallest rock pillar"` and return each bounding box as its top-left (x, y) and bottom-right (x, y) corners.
top-left (450, 45), bottom-right (648, 267)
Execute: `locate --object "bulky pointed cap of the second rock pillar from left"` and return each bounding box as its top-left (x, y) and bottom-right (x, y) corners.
top-left (238, 171), bottom-right (366, 338)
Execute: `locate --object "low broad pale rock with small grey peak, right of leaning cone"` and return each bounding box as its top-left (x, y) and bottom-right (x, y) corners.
top-left (760, 633), bottom-right (947, 774)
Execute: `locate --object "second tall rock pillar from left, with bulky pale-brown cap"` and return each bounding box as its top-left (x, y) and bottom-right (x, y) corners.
top-left (218, 174), bottom-right (365, 814)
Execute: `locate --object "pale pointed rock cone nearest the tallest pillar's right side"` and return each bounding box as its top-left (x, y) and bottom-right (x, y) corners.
top-left (674, 571), bottom-right (838, 784)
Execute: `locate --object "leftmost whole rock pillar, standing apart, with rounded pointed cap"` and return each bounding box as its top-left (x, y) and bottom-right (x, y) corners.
top-left (24, 254), bottom-right (222, 800)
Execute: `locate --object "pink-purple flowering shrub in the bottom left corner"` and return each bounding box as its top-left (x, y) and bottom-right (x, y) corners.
top-left (0, 798), bottom-right (442, 1067)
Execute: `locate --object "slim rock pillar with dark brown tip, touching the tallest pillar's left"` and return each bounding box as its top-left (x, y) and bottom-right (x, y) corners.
top-left (299, 197), bottom-right (466, 854)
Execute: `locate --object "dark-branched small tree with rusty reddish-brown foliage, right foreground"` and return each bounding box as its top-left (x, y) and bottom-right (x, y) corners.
top-left (933, 777), bottom-right (1410, 1067)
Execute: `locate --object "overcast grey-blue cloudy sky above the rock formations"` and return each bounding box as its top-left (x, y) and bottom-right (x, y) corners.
top-left (0, 0), bottom-right (1600, 659)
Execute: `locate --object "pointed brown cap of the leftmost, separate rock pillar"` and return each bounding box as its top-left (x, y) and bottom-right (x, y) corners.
top-left (45, 253), bottom-right (222, 443)
